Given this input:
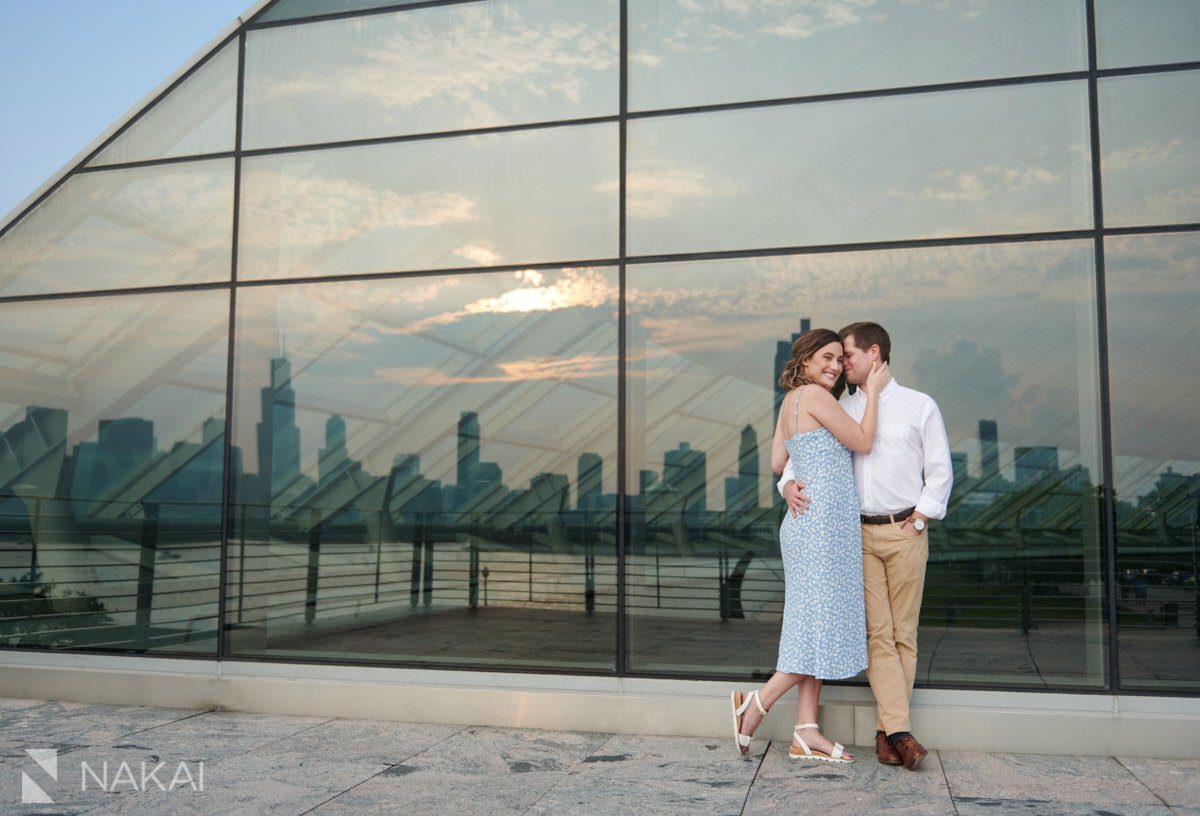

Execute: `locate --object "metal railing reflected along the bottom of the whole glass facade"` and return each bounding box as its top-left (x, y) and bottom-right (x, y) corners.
top-left (0, 485), bottom-right (1200, 667)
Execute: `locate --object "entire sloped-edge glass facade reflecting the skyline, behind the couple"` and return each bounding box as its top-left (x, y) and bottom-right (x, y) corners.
top-left (0, 0), bottom-right (1200, 694)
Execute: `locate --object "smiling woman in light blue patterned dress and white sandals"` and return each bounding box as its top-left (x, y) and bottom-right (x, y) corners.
top-left (731, 329), bottom-right (892, 762)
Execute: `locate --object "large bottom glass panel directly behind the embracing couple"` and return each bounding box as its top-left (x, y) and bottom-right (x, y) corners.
top-left (626, 241), bottom-right (1106, 689)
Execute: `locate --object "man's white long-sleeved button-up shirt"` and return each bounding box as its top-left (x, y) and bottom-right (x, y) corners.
top-left (778, 380), bottom-right (954, 518)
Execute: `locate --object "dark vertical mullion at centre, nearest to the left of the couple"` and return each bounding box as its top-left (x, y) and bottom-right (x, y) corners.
top-left (614, 0), bottom-right (629, 677)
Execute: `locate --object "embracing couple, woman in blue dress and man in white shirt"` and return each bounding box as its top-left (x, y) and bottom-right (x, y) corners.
top-left (731, 323), bottom-right (952, 770)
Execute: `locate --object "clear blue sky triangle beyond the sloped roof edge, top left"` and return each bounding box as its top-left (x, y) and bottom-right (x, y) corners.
top-left (0, 0), bottom-right (254, 218)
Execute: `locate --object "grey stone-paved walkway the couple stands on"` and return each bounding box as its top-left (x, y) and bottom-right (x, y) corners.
top-left (0, 691), bottom-right (1200, 816)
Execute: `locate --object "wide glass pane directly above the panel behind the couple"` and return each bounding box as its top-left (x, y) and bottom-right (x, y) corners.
top-left (628, 82), bottom-right (1092, 254)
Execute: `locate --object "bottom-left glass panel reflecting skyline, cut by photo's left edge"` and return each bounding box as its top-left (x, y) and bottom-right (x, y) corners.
top-left (0, 292), bottom-right (229, 656)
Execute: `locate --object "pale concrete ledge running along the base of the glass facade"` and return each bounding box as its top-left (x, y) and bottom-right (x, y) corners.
top-left (0, 652), bottom-right (1200, 758)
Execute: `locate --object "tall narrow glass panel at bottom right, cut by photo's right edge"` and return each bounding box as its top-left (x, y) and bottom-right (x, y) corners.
top-left (1105, 233), bottom-right (1200, 691)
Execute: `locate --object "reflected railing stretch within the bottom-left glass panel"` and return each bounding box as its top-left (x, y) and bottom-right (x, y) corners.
top-left (0, 498), bottom-right (221, 652)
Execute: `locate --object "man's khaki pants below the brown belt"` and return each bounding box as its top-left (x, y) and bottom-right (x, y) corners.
top-left (863, 524), bottom-right (929, 734)
